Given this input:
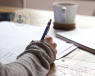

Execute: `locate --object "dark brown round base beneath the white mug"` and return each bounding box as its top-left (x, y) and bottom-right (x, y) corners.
top-left (53, 22), bottom-right (76, 30)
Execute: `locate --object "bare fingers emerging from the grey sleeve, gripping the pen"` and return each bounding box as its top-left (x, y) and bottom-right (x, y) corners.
top-left (43, 36), bottom-right (57, 54)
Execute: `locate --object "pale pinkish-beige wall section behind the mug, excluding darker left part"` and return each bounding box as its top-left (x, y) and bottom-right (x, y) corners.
top-left (26, 0), bottom-right (95, 15)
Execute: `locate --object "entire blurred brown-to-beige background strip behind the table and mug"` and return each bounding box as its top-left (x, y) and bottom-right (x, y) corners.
top-left (0, 0), bottom-right (95, 16)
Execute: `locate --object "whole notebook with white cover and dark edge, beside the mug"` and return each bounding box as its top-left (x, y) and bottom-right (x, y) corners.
top-left (56, 28), bottom-right (95, 54)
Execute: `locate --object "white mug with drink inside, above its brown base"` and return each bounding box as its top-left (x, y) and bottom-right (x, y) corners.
top-left (53, 2), bottom-right (78, 24)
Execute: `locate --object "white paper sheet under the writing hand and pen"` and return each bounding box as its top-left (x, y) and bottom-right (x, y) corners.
top-left (0, 22), bottom-right (76, 64)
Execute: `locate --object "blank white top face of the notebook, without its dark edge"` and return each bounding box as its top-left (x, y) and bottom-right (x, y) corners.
top-left (57, 28), bottom-right (95, 49)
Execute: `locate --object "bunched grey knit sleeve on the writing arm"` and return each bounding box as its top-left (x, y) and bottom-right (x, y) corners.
top-left (0, 41), bottom-right (56, 76)
